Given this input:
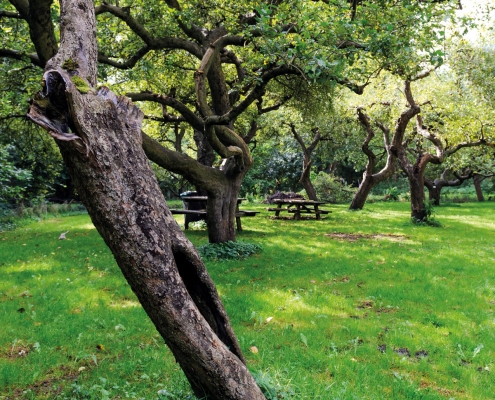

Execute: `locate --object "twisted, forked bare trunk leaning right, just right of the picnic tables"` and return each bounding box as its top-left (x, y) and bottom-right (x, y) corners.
top-left (349, 108), bottom-right (400, 210)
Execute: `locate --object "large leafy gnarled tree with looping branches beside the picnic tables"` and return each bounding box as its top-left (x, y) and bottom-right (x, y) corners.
top-left (0, 0), bottom-right (457, 242)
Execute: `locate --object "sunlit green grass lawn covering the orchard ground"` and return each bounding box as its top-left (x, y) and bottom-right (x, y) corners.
top-left (0, 203), bottom-right (495, 399)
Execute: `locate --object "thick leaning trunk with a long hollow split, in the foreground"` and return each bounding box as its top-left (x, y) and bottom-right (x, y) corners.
top-left (29, 0), bottom-right (265, 399)
